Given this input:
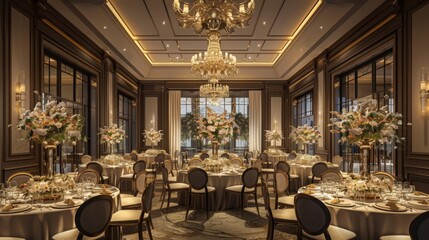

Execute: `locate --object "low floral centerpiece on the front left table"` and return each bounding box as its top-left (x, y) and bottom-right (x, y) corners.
top-left (20, 175), bottom-right (76, 200)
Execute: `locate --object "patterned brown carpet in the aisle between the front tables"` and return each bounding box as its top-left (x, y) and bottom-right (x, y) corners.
top-left (119, 180), bottom-right (296, 240)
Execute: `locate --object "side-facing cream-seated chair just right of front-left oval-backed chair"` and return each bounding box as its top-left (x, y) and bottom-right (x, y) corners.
top-left (109, 182), bottom-right (154, 240)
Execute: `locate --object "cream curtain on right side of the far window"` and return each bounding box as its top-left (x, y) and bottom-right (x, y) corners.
top-left (249, 91), bottom-right (262, 152)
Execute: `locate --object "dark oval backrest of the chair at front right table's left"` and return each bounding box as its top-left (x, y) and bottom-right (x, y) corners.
top-left (294, 193), bottom-right (331, 239)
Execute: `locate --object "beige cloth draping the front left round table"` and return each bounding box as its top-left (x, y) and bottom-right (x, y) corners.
top-left (0, 188), bottom-right (120, 240)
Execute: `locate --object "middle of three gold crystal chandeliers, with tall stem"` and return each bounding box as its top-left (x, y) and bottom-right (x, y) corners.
top-left (191, 31), bottom-right (238, 80)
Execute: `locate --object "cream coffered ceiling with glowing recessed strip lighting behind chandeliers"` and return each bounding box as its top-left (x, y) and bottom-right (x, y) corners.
top-left (48, 0), bottom-right (383, 80)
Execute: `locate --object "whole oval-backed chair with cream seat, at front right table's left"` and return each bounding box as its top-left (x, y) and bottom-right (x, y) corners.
top-left (295, 193), bottom-right (357, 240)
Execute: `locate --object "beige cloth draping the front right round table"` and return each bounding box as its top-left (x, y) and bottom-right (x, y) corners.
top-left (299, 188), bottom-right (424, 240)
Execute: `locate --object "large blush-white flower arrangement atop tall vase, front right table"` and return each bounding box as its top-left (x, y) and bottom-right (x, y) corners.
top-left (328, 96), bottom-right (411, 145)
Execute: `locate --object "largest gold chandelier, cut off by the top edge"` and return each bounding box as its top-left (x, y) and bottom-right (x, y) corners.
top-left (173, 0), bottom-right (255, 34)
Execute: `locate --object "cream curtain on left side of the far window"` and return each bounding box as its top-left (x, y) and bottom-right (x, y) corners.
top-left (168, 91), bottom-right (181, 158)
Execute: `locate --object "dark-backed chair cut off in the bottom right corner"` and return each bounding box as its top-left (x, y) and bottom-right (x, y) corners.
top-left (380, 211), bottom-right (429, 240)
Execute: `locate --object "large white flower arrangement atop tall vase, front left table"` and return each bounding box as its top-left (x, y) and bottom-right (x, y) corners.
top-left (16, 91), bottom-right (84, 145)
